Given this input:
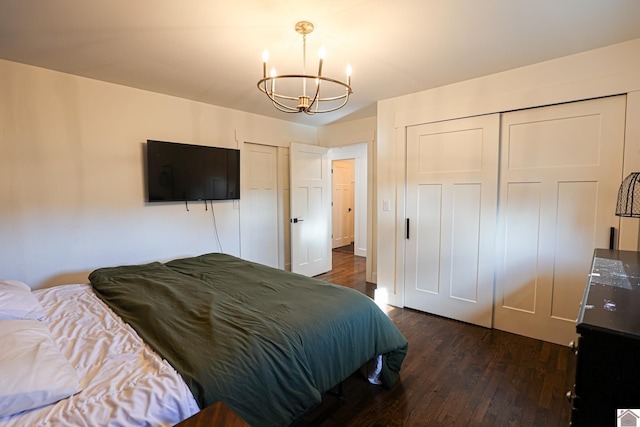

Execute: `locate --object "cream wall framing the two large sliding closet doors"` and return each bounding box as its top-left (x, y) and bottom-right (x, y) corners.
top-left (375, 39), bottom-right (640, 305)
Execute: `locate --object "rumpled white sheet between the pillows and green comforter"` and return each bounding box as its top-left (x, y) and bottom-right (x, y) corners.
top-left (0, 285), bottom-right (199, 427)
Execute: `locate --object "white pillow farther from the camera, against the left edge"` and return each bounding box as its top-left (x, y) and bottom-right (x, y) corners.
top-left (0, 280), bottom-right (45, 320)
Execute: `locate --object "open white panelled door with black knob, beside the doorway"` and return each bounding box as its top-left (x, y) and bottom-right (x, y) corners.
top-left (289, 143), bottom-right (331, 276)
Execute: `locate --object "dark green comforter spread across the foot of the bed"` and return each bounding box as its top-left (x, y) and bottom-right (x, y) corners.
top-left (89, 253), bottom-right (408, 426)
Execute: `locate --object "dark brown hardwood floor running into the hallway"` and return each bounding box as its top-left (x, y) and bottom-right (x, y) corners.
top-left (299, 249), bottom-right (576, 427)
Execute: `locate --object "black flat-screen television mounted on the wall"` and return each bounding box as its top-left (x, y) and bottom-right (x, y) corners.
top-left (147, 140), bottom-right (240, 202)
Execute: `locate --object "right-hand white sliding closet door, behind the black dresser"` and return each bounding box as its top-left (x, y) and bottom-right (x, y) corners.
top-left (494, 96), bottom-right (625, 345)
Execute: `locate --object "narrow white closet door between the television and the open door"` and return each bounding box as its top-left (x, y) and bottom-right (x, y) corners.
top-left (240, 143), bottom-right (280, 268)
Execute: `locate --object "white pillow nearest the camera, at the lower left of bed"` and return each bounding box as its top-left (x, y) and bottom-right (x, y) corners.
top-left (0, 319), bottom-right (80, 417)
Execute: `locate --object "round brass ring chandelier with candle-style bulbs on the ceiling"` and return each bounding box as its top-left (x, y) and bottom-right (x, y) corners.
top-left (258, 21), bottom-right (353, 115)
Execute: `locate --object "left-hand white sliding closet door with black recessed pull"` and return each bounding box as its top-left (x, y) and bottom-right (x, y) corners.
top-left (405, 114), bottom-right (500, 327)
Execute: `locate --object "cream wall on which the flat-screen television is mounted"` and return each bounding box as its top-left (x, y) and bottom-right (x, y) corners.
top-left (0, 60), bottom-right (317, 288)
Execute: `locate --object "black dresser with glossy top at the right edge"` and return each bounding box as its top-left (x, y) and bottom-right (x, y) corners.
top-left (568, 249), bottom-right (640, 427)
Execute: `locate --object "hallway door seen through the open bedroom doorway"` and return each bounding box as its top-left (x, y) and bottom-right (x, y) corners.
top-left (331, 159), bottom-right (355, 248)
